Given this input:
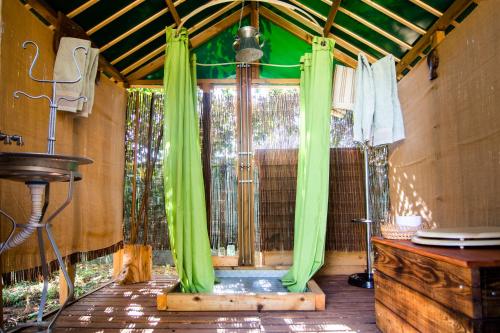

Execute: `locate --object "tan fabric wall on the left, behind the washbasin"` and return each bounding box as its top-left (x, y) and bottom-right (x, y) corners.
top-left (0, 0), bottom-right (126, 272)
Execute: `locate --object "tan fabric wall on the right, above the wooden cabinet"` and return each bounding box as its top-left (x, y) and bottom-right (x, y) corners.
top-left (389, 0), bottom-right (500, 226)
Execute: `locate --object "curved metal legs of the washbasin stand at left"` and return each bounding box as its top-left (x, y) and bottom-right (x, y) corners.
top-left (0, 172), bottom-right (75, 333)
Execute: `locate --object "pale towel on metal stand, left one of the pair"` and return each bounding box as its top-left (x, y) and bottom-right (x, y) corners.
top-left (353, 53), bottom-right (375, 143)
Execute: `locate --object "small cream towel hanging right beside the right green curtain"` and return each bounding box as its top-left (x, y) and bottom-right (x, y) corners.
top-left (332, 65), bottom-right (356, 118)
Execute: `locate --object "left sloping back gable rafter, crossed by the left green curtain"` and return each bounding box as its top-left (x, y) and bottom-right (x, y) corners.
top-left (127, 6), bottom-right (250, 81)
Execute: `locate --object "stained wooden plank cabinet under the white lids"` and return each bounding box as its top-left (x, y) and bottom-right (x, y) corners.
top-left (373, 237), bottom-right (500, 333)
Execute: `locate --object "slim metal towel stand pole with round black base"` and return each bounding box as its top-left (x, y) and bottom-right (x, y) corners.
top-left (348, 145), bottom-right (373, 289)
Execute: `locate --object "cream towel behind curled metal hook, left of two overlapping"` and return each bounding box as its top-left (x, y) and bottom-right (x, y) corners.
top-left (54, 37), bottom-right (90, 112)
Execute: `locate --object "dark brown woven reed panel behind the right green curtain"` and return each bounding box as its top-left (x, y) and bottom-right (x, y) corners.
top-left (255, 148), bottom-right (365, 251)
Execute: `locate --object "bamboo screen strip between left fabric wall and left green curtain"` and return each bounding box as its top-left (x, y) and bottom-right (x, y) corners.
top-left (124, 89), bottom-right (169, 249)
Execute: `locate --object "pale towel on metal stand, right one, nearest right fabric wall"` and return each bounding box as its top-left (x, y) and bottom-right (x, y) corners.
top-left (371, 54), bottom-right (405, 146)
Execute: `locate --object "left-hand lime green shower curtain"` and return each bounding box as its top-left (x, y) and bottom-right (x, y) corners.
top-left (163, 29), bottom-right (214, 292)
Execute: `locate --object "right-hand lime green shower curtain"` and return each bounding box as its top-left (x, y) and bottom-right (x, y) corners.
top-left (282, 37), bottom-right (335, 292)
